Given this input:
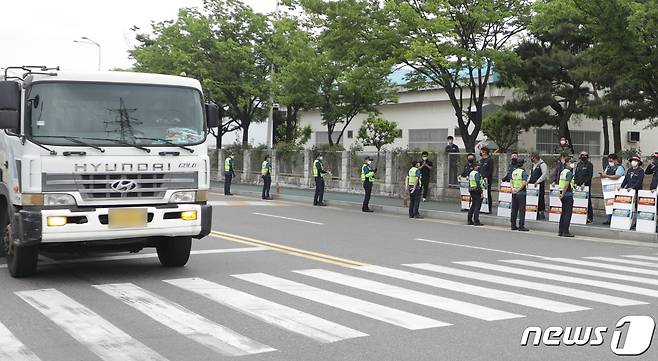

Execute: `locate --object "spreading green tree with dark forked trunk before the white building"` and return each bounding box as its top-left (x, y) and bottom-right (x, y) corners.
top-left (380, 0), bottom-right (532, 151)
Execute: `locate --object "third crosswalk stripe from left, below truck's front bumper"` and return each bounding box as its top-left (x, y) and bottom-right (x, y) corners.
top-left (94, 283), bottom-right (276, 356)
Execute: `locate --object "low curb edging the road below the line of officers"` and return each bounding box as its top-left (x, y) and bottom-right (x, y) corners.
top-left (227, 189), bottom-right (658, 243)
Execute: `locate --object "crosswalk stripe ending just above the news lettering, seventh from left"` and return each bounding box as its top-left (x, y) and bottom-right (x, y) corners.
top-left (356, 266), bottom-right (589, 313)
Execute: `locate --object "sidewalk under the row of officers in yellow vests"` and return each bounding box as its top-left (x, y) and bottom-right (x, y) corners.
top-left (211, 181), bottom-right (658, 243)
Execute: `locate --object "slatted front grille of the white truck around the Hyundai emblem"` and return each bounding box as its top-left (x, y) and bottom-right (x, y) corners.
top-left (42, 173), bottom-right (198, 201)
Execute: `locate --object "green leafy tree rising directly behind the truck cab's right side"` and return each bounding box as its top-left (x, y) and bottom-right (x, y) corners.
top-left (130, 0), bottom-right (271, 144)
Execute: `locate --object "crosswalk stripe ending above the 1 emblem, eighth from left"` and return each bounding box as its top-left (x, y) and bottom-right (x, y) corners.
top-left (404, 263), bottom-right (647, 306)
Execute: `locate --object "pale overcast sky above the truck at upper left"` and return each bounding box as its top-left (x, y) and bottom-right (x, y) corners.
top-left (0, 0), bottom-right (276, 143)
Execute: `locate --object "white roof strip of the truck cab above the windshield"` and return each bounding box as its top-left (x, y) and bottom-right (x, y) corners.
top-left (25, 71), bottom-right (201, 90)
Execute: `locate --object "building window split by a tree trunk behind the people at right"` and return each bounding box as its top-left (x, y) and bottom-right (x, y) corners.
top-left (537, 129), bottom-right (601, 155)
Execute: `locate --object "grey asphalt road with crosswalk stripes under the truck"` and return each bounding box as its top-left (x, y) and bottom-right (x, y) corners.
top-left (0, 196), bottom-right (658, 361)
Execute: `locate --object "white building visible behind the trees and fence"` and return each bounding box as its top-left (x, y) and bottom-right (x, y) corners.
top-left (301, 69), bottom-right (658, 156)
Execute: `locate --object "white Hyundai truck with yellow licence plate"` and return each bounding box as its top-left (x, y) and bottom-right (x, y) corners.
top-left (0, 67), bottom-right (219, 277)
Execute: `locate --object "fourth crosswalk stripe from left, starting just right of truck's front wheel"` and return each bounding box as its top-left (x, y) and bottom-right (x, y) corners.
top-left (165, 278), bottom-right (368, 343)
